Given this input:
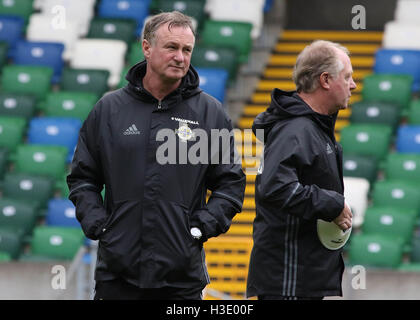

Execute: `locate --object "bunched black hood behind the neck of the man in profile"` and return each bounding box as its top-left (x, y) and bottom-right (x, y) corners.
top-left (252, 89), bottom-right (338, 141)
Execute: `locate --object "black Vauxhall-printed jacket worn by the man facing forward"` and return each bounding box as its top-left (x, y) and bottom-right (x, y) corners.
top-left (67, 61), bottom-right (245, 288)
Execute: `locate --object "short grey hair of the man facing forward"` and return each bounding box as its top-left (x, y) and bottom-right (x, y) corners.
top-left (141, 11), bottom-right (195, 44)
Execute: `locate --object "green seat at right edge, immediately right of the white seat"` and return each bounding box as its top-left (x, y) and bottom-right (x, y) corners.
top-left (372, 180), bottom-right (420, 214)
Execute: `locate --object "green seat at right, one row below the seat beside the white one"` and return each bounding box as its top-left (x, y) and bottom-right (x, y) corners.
top-left (362, 206), bottom-right (416, 246)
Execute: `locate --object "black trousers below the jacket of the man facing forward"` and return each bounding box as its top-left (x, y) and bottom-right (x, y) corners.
top-left (94, 279), bottom-right (203, 300)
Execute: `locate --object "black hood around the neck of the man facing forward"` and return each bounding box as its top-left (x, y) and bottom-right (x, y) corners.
top-left (125, 60), bottom-right (202, 103)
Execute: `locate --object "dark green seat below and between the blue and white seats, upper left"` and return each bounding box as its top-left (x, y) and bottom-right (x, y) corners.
top-left (60, 68), bottom-right (110, 97)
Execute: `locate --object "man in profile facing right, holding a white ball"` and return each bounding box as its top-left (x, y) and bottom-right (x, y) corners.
top-left (247, 40), bottom-right (356, 300)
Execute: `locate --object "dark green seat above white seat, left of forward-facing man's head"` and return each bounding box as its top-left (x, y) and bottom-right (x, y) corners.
top-left (87, 17), bottom-right (137, 45)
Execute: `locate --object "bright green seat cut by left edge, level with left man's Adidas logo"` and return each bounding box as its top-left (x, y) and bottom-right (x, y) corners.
top-left (0, 116), bottom-right (27, 151)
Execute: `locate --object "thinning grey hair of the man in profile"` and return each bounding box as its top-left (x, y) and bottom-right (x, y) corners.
top-left (293, 40), bottom-right (350, 93)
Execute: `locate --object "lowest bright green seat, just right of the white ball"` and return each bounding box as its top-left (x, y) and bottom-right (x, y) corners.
top-left (349, 234), bottom-right (403, 268)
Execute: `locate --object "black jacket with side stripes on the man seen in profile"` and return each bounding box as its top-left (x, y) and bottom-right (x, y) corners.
top-left (247, 89), bottom-right (344, 297)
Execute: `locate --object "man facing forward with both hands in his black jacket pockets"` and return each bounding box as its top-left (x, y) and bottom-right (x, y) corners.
top-left (67, 12), bottom-right (245, 299)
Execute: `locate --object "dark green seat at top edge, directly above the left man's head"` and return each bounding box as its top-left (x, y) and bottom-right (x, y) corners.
top-left (151, 0), bottom-right (206, 29)
